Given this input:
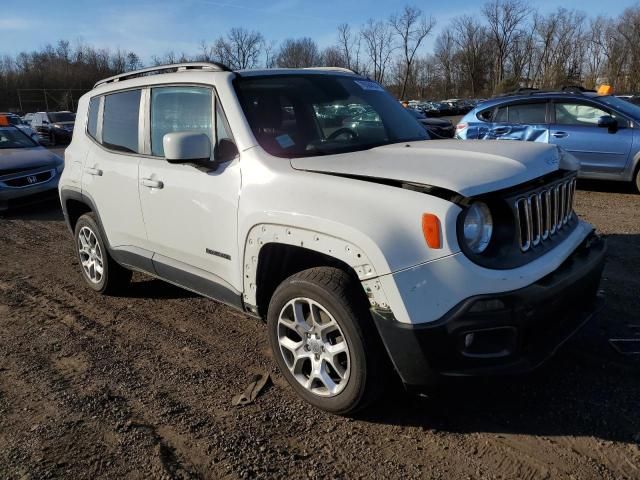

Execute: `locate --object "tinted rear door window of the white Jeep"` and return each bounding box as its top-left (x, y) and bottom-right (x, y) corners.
top-left (102, 90), bottom-right (140, 153)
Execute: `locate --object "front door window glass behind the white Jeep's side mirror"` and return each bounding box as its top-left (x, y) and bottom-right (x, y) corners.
top-left (151, 87), bottom-right (214, 157)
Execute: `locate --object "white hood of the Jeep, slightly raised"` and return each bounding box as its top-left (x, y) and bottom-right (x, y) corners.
top-left (291, 140), bottom-right (578, 197)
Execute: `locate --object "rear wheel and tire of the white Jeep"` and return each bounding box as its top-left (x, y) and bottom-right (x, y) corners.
top-left (74, 213), bottom-right (132, 294)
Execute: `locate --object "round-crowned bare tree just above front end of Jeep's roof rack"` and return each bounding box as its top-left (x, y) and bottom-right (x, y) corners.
top-left (213, 28), bottom-right (264, 70)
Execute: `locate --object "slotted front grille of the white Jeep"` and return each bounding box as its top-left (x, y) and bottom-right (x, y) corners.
top-left (514, 177), bottom-right (576, 252)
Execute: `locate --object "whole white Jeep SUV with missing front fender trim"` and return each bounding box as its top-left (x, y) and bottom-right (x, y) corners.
top-left (60, 63), bottom-right (605, 414)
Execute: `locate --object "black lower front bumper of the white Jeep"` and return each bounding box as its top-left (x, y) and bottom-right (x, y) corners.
top-left (372, 235), bottom-right (606, 386)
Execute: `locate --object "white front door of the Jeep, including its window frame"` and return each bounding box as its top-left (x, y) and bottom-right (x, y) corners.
top-left (139, 86), bottom-right (241, 300)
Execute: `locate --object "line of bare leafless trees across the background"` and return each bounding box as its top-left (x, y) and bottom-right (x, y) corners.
top-left (0, 0), bottom-right (640, 110)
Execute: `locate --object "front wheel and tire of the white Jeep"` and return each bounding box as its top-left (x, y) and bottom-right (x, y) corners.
top-left (267, 267), bottom-right (389, 415)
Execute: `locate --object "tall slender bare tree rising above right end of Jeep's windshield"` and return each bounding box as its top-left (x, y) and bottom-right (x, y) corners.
top-left (389, 6), bottom-right (435, 100)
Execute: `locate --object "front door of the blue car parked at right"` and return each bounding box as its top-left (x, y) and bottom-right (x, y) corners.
top-left (549, 99), bottom-right (633, 175)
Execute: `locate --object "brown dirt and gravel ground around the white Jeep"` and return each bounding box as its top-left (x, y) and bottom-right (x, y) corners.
top-left (0, 174), bottom-right (640, 479)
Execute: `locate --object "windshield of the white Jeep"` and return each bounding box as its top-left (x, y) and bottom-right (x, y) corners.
top-left (235, 75), bottom-right (428, 157)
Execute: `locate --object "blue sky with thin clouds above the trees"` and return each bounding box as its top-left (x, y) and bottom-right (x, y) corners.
top-left (0, 0), bottom-right (636, 61)
